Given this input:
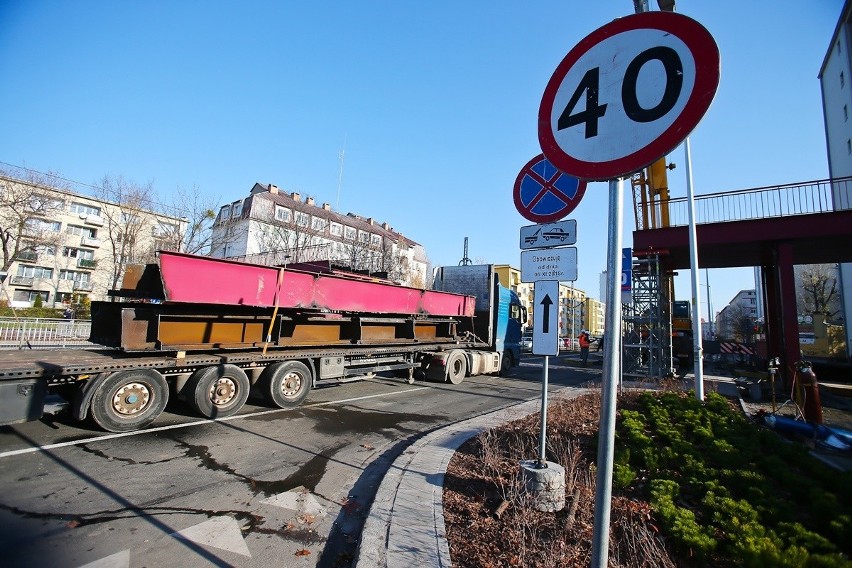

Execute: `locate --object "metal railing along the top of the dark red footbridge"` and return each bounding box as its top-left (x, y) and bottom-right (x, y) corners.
top-left (640, 177), bottom-right (852, 231)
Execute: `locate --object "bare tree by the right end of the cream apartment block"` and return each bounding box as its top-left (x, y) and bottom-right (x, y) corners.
top-left (96, 176), bottom-right (154, 289)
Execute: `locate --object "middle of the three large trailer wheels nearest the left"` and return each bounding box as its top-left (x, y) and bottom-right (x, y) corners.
top-left (184, 365), bottom-right (251, 418)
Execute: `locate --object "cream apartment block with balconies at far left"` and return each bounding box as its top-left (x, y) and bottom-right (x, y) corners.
top-left (0, 176), bottom-right (187, 308)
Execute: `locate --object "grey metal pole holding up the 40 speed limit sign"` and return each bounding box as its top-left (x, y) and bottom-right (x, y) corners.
top-left (591, 178), bottom-right (624, 568)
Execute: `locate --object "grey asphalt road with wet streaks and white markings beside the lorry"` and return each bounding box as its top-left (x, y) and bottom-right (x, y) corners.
top-left (0, 356), bottom-right (600, 568)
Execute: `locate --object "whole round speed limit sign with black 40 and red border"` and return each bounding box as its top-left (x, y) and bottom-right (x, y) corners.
top-left (538, 12), bottom-right (719, 180)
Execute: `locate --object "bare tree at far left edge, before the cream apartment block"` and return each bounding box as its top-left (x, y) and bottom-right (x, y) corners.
top-left (0, 170), bottom-right (67, 270)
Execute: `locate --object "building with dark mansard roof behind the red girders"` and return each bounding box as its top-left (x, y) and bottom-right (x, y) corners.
top-left (210, 183), bottom-right (428, 288)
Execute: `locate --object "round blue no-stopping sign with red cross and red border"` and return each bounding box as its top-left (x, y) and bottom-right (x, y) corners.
top-left (512, 154), bottom-right (586, 223)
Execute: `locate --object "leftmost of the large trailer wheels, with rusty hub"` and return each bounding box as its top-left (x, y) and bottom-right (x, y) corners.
top-left (91, 369), bottom-right (169, 432)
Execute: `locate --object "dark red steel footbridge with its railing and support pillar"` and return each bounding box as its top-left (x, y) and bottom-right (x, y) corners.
top-left (633, 178), bottom-right (852, 385)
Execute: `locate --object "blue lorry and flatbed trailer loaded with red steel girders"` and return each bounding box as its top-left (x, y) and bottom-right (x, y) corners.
top-left (0, 251), bottom-right (526, 432)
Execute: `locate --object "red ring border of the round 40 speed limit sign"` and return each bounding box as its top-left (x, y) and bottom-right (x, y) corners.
top-left (538, 12), bottom-right (720, 181)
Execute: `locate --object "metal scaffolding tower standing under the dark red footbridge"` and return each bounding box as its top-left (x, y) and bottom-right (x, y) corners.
top-left (622, 254), bottom-right (674, 379)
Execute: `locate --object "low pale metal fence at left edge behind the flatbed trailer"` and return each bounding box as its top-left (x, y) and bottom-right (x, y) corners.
top-left (0, 317), bottom-right (96, 349)
